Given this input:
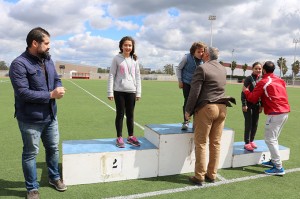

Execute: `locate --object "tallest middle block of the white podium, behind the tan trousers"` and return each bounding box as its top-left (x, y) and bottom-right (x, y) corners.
top-left (145, 123), bottom-right (234, 176)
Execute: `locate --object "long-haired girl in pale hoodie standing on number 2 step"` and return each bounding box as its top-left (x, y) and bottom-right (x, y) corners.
top-left (107, 36), bottom-right (141, 148)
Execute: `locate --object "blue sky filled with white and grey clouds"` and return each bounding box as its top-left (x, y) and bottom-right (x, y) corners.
top-left (0, 0), bottom-right (300, 74)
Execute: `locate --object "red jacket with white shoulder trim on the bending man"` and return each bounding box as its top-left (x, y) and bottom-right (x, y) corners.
top-left (244, 73), bottom-right (290, 115)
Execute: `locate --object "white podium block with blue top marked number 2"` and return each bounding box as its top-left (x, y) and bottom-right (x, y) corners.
top-left (62, 138), bottom-right (158, 185)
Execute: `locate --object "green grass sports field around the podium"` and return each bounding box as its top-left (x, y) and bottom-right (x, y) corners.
top-left (0, 78), bottom-right (300, 199)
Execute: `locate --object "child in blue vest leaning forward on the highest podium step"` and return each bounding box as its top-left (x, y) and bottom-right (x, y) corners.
top-left (176, 42), bottom-right (206, 130)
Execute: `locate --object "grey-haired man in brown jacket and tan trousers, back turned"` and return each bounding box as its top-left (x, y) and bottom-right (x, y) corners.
top-left (185, 47), bottom-right (235, 186)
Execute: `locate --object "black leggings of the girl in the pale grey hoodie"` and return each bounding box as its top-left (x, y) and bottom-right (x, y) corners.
top-left (114, 91), bottom-right (136, 137)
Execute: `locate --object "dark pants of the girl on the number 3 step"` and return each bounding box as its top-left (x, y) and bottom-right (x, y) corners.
top-left (243, 106), bottom-right (259, 144)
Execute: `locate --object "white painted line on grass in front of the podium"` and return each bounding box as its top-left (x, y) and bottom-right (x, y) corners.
top-left (106, 168), bottom-right (300, 199)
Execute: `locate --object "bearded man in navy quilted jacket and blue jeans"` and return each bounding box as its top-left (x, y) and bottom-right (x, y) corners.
top-left (9, 27), bottom-right (67, 198)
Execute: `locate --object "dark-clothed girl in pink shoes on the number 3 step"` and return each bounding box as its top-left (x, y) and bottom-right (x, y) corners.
top-left (241, 62), bottom-right (262, 151)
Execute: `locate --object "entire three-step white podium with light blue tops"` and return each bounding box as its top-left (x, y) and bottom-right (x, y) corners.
top-left (62, 123), bottom-right (290, 185)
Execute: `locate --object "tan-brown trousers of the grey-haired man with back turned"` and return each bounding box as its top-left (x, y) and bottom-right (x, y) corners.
top-left (194, 104), bottom-right (227, 181)
